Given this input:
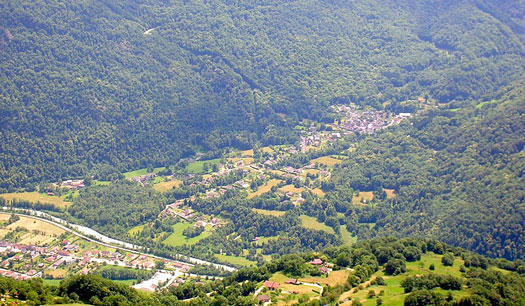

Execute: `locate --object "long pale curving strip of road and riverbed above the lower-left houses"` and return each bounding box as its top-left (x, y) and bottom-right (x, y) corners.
top-left (2, 206), bottom-right (237, 272)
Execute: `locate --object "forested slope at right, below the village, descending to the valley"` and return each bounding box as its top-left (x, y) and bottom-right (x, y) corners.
top-left (334, 82), bottom-right (525, 258)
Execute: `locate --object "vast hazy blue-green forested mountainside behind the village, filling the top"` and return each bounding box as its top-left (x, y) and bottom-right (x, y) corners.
top-left (0, 0), bottom-right (524, 189)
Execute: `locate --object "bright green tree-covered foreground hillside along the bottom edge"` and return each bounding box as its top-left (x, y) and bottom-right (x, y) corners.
top-left (0, 238), bottom-right (525, 305)
